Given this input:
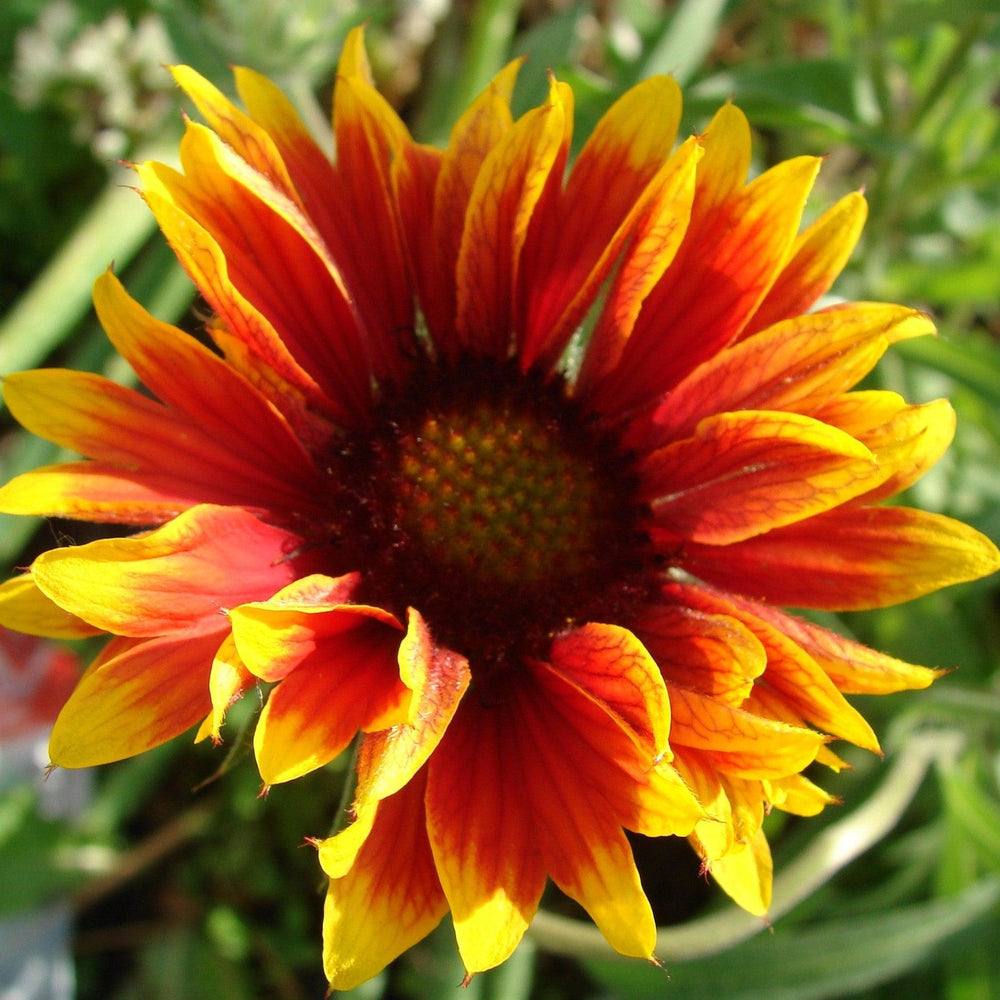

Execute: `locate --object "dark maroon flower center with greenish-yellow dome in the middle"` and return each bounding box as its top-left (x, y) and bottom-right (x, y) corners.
top-left (344, 360), bottom-right (655, 670)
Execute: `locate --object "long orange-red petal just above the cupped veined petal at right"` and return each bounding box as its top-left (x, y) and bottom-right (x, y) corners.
top-left (631, 303), bottom-right (934, 447)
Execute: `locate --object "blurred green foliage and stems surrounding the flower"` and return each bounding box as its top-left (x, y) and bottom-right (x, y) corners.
top-left (0, 0), bottom-right (1000, 1000)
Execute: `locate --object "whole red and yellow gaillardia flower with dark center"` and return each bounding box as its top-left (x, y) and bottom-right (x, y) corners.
top-left (0, 32), bottom-right (998, 988)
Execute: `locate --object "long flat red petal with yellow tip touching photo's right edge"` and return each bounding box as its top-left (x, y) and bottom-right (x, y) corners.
top-left (684, 505), bottom-right (1000, 611)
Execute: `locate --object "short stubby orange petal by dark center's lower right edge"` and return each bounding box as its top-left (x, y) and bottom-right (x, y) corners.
top-left (633, 606), bottom-right (767, 706)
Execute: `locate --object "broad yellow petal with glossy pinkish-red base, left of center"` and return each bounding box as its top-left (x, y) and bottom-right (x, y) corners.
top-left (32, 506), bottom-right (299, 636)
